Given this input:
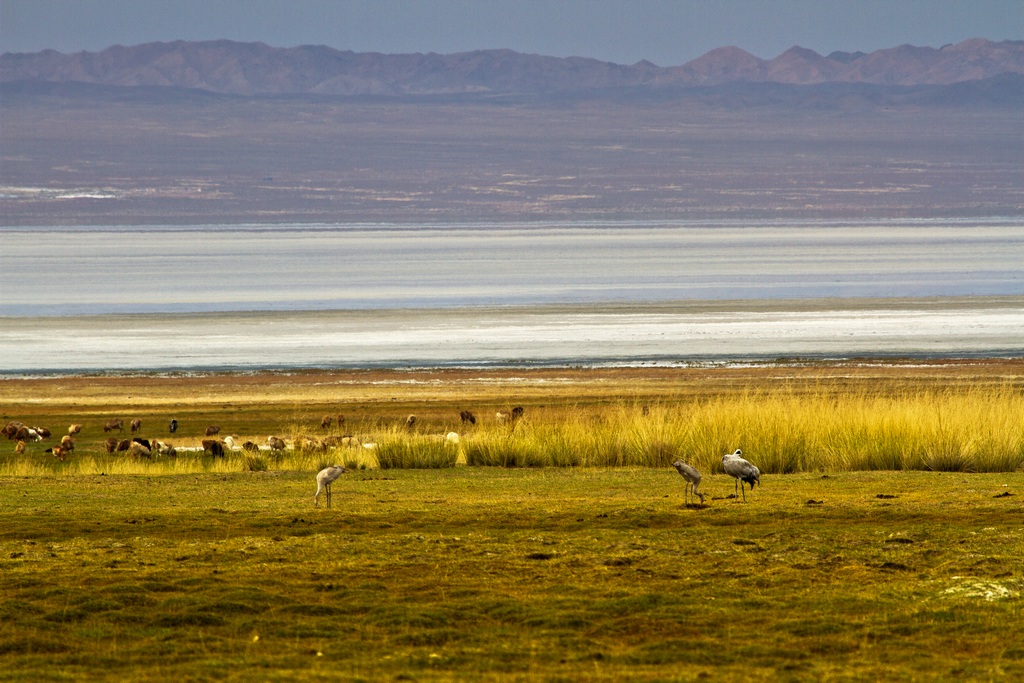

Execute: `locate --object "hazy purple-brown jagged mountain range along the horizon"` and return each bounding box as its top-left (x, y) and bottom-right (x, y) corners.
top-left (6, 38), bottom-right (1024, 96)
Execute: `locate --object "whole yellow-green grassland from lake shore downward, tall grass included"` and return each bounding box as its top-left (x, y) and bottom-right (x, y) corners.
top-left (0, 359), bottom-right (1024, 681)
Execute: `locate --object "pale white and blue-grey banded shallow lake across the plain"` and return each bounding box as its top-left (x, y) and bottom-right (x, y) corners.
top-left (0, 219), bottom-right (1024, 373)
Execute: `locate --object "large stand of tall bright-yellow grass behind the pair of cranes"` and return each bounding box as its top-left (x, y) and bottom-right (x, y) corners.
top-left (456, 387), bottom-right (1024, 474)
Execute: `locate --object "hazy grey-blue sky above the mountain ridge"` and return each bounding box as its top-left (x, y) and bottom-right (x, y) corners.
top-left (0, 0), bottom-right (1024, 66)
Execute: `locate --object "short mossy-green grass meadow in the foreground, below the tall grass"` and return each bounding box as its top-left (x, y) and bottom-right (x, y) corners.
top-left (0, 466), bottom-right (1024, 681)
